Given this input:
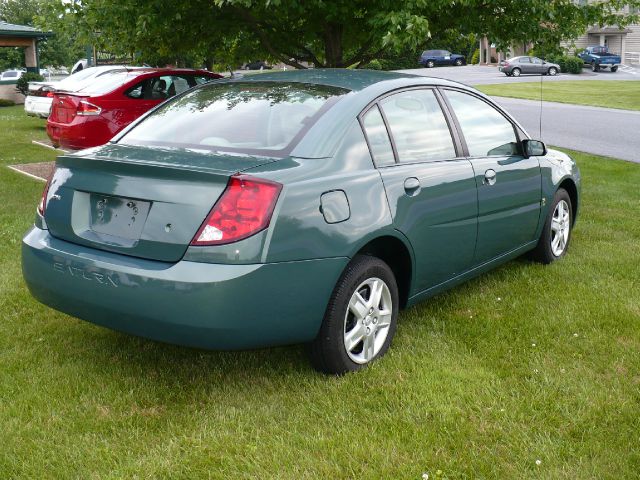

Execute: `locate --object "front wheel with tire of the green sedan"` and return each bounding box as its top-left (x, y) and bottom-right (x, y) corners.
top-left (531, 188), bottom-right (573, 264)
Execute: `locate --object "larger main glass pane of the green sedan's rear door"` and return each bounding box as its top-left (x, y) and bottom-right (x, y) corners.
top-left (380, 89), bottom-right (456, 162)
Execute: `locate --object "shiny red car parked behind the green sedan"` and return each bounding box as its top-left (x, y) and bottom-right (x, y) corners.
top-left (47, 68), bottom-right (221, 150)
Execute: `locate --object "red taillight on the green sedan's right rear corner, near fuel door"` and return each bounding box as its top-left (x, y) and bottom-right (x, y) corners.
top-left (191, 175), bottom-right (282, 245)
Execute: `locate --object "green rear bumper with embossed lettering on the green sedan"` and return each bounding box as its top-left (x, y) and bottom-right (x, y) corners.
top-left (22, 227), bottom-right (349, 350)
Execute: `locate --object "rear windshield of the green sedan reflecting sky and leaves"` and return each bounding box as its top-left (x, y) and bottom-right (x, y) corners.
top-left (119, 82), bottom-right (348, 155)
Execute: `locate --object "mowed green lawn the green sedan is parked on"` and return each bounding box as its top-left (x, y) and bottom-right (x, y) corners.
top-left (0, 107), bottom-right (640, 479)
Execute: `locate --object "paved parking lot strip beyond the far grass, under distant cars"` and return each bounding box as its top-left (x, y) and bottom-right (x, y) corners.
top-left (398, 65), bottom-right (640, 85)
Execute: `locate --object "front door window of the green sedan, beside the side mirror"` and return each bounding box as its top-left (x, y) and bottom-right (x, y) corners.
top-left (445, 90), bottom-right (520, 157)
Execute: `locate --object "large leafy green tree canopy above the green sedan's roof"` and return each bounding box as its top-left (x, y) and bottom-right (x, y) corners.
top-left (52, 0), bottom-right (640, 68)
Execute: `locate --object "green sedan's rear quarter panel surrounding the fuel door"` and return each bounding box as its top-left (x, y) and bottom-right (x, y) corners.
top-left (247, 120), bottom-right (393, 262)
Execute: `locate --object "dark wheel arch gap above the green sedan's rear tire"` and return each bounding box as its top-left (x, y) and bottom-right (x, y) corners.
top-left (353, 233), bottom-right (414, 308)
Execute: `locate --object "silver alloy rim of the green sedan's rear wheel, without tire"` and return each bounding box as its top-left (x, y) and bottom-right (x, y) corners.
top-left (344, 277), bottom-right (393, 364)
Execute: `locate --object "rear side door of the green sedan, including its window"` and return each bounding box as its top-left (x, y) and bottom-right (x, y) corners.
top-left (361, 88), bottom-right (478, 293)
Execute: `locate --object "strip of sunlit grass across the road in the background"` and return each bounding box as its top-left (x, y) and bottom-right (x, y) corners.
top-left (476, 80), bottom-right (640, 110)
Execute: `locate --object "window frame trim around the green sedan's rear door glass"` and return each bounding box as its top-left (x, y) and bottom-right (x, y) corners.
top-left (357, 85), bottom-right (468, 168)
